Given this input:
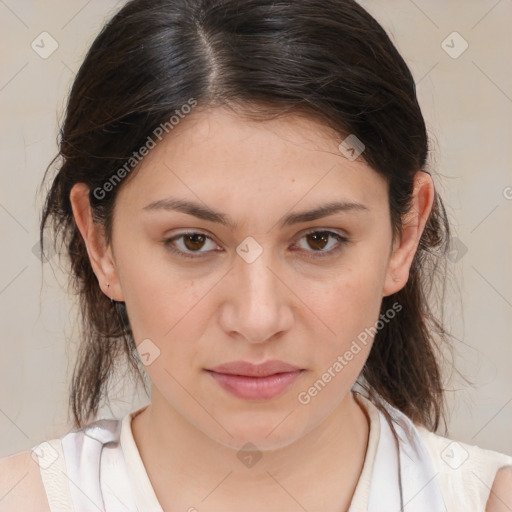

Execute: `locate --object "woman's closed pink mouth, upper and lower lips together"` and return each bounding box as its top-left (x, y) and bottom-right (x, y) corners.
top-left (207, 360), bottom-right (304, 400)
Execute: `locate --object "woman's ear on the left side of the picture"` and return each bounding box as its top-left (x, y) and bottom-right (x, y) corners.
top-left (69, 183), bottom-right (124, 301)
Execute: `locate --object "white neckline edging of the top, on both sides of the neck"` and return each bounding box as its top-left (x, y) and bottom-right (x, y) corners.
top-left (120, 392), bottom-right (380, 512)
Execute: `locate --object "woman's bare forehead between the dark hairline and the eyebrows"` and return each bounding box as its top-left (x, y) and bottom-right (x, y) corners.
top-left (116, 108), bottom-right (387, 219)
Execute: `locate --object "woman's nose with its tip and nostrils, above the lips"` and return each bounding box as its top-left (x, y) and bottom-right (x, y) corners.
top-left (220, 251), bottom-right (293, 343)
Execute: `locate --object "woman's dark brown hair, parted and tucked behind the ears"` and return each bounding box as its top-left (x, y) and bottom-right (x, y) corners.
top-left (40, 0), bottom-right (450, 430)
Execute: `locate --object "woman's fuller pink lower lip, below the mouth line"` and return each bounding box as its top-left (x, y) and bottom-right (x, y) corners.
top-left (205, 370), bottom-right (303, 400)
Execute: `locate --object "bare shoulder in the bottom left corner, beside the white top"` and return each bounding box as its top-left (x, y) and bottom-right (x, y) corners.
top-left (0, 451), bottom-right (50, 512)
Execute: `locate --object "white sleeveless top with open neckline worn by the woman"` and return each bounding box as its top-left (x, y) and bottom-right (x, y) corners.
top-left (32, 393), bottom-right (512, 512)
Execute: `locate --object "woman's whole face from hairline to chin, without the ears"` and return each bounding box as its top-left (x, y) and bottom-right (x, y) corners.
top-left (77, 109), bottom-right (421, 449)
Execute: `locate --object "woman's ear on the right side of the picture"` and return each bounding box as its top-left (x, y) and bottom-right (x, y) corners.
top-left (382, 171), bottom-right (434, 297)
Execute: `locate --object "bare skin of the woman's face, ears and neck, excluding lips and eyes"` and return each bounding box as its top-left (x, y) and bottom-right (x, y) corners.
top-left (70, 108), bottom-right (434, 512)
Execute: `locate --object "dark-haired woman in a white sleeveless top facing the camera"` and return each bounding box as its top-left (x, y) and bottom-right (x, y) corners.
top-left (0, 0), bottom-right (512, 512)
